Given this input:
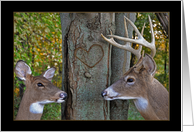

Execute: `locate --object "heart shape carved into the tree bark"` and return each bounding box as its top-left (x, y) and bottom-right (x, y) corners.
top-left (74, 44), bottom-right (104, 68)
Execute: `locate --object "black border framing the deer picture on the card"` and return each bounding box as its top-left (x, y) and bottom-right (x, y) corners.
top-left (1, 1), bottom-right (181, 131)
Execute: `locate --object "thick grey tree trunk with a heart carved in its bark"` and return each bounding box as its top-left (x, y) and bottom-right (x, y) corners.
top-left (60, 13), bottom-right (114, 120)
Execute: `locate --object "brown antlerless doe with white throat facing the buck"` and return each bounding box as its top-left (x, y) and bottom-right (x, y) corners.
top-left (15, 60), bottom-right (67, 120)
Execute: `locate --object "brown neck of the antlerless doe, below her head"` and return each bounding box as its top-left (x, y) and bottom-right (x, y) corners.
top-left (16, 89), bottom-right (44, 120)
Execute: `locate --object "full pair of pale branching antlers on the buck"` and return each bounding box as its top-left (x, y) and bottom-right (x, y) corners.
top-left (101, 16), bottom-right (156, 59)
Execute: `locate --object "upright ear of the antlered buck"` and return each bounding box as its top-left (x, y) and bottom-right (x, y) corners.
top-left (143, 54), bottom-right (156, 76)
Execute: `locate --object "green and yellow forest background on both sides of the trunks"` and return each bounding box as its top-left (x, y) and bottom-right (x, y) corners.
top-left (13, 12), bottom-right (169, 120)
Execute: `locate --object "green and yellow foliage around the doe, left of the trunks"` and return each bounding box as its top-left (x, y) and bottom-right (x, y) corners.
top-left (14, 12), bottom-right (62, 120)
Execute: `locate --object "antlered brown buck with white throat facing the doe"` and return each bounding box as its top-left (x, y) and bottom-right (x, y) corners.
top-left (101, 16), bottom-right (169, 120)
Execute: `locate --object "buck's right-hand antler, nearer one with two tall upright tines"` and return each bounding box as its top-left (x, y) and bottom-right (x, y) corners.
top-left (108, 16), bottom-right (156, 58)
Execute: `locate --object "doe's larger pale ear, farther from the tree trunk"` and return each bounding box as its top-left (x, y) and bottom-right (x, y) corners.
top-left (15, 60), bottom-right (32, 80)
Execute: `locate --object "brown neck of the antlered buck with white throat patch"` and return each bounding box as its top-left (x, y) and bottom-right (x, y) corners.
top-left (134, 79), bottom-right (169, 120)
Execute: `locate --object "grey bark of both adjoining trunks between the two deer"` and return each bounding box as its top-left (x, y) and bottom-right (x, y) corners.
top-left (60, 13), bottom-right (140, 120)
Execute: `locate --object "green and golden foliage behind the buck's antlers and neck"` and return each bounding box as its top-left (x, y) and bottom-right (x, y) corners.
top-left (135, 13), bottom-right (169, 90)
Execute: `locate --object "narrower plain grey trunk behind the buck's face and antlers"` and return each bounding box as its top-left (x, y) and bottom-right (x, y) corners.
top-left (110, 13), bottom-right (142, 120)
